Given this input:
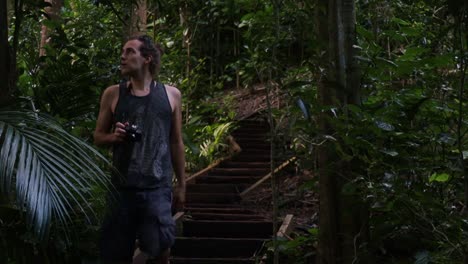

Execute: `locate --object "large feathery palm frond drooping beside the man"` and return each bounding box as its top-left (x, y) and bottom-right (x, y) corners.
top-left (0, 110), bottom-right (109, 237)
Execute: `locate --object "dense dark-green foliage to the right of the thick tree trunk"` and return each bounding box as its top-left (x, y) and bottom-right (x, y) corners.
top-left (278, 1), bottom-right (468, 263)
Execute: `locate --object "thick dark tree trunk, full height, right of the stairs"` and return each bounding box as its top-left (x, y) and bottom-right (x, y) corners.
top-left (317, 0), bottom-right (367, 264)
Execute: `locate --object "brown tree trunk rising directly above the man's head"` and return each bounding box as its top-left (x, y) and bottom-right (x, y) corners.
top-left (123, 0), bottom-right (147, 40)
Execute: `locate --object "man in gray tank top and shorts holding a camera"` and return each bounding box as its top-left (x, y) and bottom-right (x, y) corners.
top-left (94, 36), bottom-right (185, 264)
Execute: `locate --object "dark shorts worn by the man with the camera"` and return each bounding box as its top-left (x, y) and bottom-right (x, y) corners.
top-left (100, 188), bottom-right (175, 262)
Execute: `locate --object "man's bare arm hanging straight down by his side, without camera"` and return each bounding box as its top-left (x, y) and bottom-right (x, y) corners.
top-left (166, 87), bottom-right (186, 210)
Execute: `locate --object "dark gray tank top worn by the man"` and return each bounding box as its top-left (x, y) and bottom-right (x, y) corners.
top-left (113, 81), bottom-right (173, 189)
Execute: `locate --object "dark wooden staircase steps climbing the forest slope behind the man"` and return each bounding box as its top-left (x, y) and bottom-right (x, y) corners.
top-left (171, 118), bottom-right (288, 264)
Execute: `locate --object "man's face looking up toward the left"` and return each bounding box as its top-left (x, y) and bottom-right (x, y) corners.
top-left (120, 39), bottom-right (148, 75)
